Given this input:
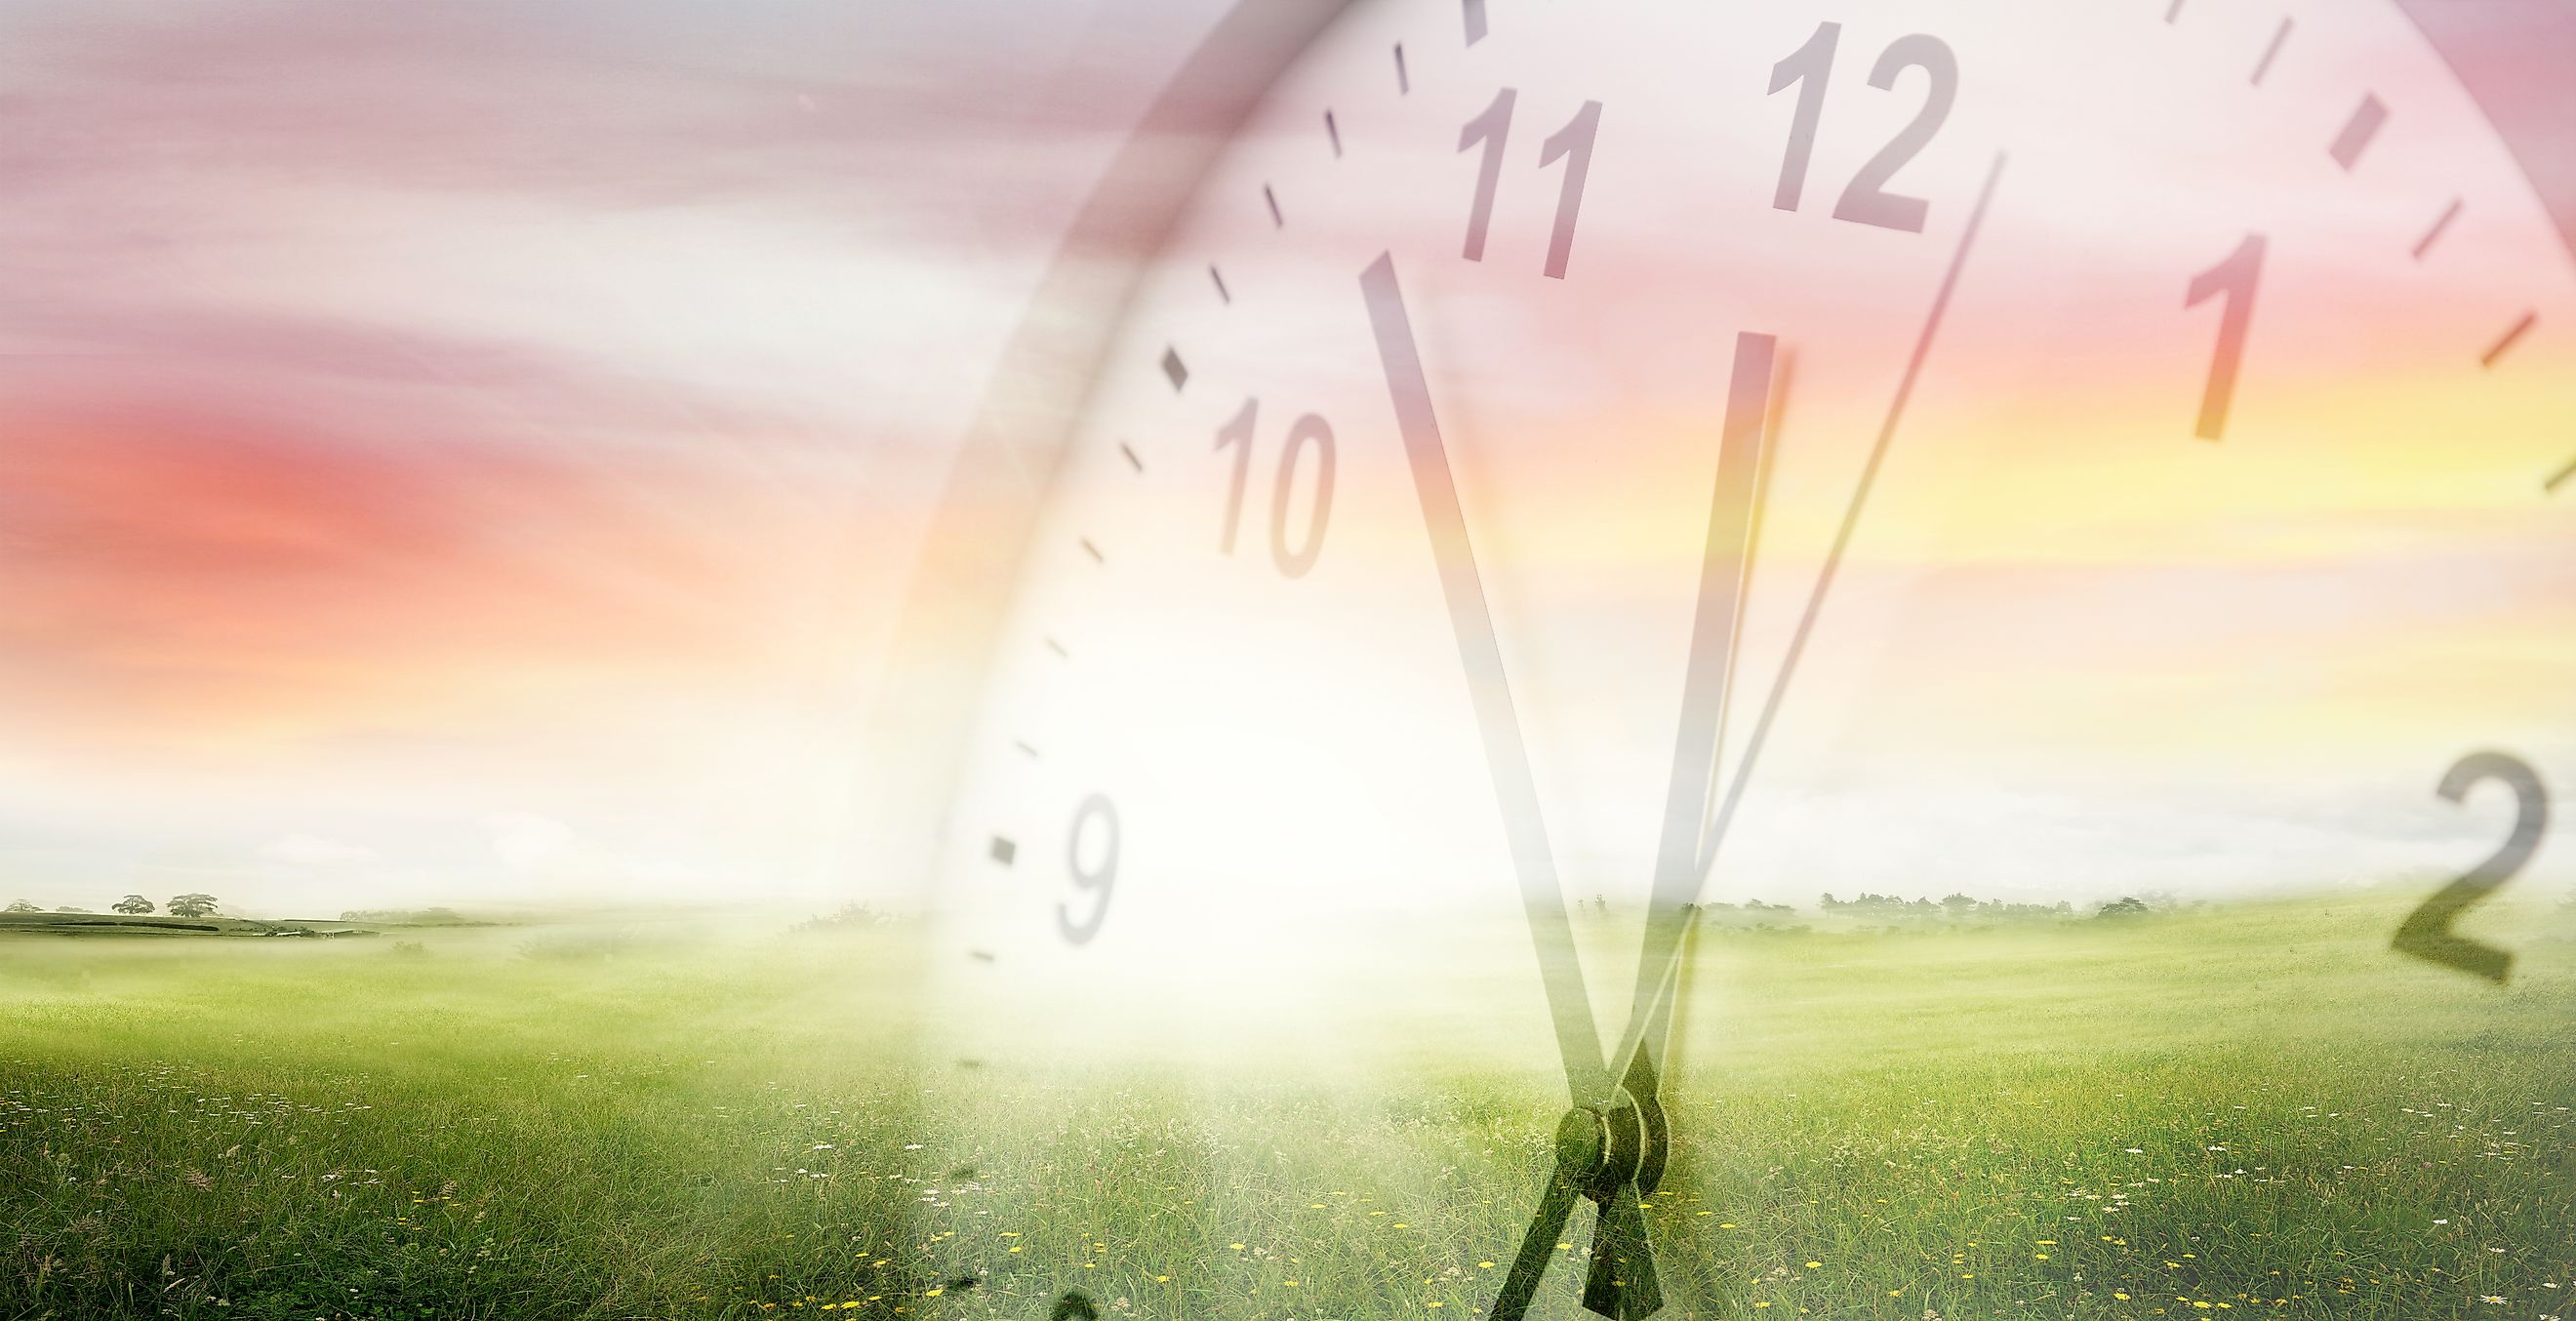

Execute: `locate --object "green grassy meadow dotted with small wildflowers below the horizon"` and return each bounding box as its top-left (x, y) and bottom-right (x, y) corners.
top-left (0, 897), bottom-right (2576, 1321)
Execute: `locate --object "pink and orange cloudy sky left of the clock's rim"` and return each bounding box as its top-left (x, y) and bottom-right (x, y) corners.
top-left (0, 0), bottom-right (1236, 911)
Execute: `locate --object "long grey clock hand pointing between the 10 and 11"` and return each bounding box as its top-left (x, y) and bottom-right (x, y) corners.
top-left (1360, 253), bottom-right (1610, 1104)
